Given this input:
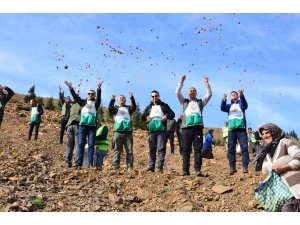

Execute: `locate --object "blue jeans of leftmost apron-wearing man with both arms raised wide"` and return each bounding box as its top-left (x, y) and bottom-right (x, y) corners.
top-left (75, 125), bottom-right (97, 166)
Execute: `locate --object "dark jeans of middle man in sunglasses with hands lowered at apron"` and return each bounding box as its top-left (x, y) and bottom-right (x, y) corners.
top-left (148, 131), bottom-right (167, 170)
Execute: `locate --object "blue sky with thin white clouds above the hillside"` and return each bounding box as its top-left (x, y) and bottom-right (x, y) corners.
top-left (0, 13), bottom-right (300, 136)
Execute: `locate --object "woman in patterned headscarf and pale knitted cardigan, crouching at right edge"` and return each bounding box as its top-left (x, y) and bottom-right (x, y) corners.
top-left (257, 123), bottom-right (300, 212)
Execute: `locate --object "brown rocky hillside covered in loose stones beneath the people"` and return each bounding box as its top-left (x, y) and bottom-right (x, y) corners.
top-left (0, 95), bottom-right (284, 212)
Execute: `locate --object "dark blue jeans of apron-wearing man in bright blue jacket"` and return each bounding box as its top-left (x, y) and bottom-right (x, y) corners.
top-left (228, 129), bottom-right (249, 170)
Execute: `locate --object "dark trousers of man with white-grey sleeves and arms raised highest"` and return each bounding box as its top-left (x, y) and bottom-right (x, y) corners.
top-left (181, 127), bottom-right (203, 173)
